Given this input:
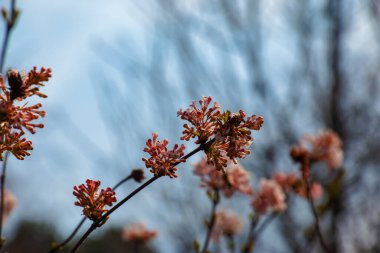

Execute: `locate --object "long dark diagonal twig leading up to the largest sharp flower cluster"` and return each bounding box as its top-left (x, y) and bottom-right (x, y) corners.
top-left (71, 140), bottom-right (209, 253)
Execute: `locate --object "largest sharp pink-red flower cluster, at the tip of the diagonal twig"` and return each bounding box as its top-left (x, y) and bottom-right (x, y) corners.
top-left (177, 97), bottom-right (264, 170)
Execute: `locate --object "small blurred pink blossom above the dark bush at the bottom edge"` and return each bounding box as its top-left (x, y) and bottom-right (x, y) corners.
top-left (122, 223), bottom-right (158, 243)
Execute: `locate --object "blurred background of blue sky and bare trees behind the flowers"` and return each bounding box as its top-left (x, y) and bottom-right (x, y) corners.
top-left (0, 0), bottom-right (380, 253)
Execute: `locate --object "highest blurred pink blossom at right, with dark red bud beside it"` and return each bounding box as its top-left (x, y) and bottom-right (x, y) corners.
top-left (291, 130), bottom-right (343, 169)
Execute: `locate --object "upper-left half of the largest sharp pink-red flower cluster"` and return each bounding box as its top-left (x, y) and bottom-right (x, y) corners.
top-left (177, 97), bottom-right (220, 144)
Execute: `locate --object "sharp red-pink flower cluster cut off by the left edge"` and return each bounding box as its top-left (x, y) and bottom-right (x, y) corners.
top-left (0, 67), bottom-right (51, 160)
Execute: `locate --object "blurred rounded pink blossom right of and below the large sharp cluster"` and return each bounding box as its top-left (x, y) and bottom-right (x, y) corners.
top-left (252, 179), bottom-right (286, 214)
